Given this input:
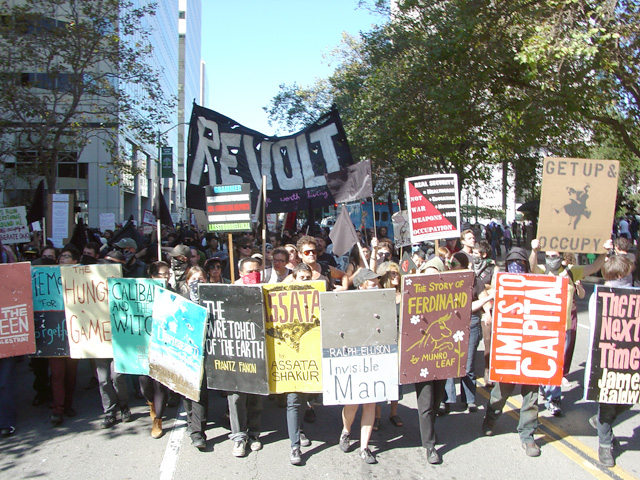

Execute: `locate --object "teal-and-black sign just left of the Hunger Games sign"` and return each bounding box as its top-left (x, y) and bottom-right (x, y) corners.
top-left (31, 265), bottom-right (69, 357)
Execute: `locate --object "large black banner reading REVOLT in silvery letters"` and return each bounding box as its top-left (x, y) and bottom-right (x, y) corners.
top-left (187, 103), bottom-right (353, 213)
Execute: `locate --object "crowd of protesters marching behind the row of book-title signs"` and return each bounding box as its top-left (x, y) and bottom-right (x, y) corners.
top-left (0, 216), bottom-right (638, 466)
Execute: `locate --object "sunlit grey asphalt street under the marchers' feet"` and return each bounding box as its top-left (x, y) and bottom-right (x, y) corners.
top-left (0, 289), bottom-right (640, 480)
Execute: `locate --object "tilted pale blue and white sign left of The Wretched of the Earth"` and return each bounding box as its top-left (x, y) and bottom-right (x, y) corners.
top-left (149, 287), bottom-right (207, 401)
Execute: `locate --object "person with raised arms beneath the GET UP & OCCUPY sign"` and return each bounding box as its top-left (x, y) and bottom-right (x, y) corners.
top-left (529, 238), bottom-right (613, 417)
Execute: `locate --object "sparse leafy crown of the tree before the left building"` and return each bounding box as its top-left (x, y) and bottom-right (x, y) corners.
top-left (0, 0), bottom-right (173, 195)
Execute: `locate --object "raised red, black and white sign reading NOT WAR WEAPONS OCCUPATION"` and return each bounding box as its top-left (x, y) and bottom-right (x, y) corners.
top-left (405, 174), bottom-right (460, 243)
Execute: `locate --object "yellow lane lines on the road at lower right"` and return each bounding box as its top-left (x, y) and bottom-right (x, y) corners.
top-left (477, 379), bottom-right (636, 480)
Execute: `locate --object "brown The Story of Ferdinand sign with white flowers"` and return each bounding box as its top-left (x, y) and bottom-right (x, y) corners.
top-left (399, 271), bottom-right (474, 385)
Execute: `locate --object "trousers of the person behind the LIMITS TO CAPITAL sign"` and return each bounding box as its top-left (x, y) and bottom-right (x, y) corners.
top-left (486, 383), bottom-right (539, 443)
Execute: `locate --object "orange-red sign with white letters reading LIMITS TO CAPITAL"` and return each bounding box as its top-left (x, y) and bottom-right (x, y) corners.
top-left (489, 273), bottom-right (569, 386)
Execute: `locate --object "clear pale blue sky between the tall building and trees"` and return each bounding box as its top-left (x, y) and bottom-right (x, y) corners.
top-left (202, 0), bottom-right (385, 135)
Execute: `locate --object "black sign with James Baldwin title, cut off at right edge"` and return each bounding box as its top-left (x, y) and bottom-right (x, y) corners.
top-left (584, 285), bottom-right (640, 404)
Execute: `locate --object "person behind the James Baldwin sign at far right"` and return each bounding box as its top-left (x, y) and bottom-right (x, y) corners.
top-left (584, 255), bottom-right (634, 467)
